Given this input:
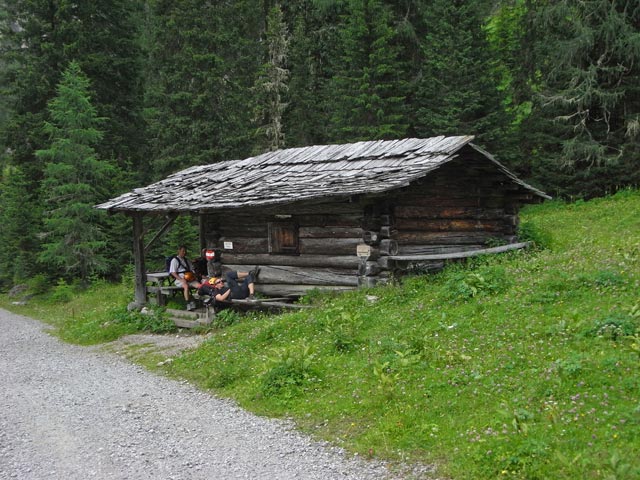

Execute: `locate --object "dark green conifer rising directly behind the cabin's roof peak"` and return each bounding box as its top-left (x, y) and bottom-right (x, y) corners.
top-left (413, 0), bottom-right (504, 150)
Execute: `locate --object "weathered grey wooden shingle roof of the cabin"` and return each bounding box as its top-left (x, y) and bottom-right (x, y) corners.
top-left (97, 136), bottom-right (548, 213)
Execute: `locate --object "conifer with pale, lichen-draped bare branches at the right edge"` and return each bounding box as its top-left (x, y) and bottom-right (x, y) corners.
top-left (539, 0), bottom-right (640, 196)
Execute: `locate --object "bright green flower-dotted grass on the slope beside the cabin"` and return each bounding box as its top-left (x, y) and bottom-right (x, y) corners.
top-left (1, 191), bottom-right (640, 479)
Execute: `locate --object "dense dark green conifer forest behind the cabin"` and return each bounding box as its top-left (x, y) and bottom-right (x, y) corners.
top-left (0, 0), bottom-right (640, 290)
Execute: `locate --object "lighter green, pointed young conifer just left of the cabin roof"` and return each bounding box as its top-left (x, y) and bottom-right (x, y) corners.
top-left (36, 62), bottom-right (117, 282)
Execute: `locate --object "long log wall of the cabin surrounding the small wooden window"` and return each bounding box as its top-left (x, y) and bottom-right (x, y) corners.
top-left (204, 203), bottom-right (363, 296)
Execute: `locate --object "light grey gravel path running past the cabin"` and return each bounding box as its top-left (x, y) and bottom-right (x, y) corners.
top-left (0, 309), bottom-right (436, 480)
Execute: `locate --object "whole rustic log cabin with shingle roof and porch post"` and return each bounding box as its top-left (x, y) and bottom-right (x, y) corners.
top-left (98, 136), bottom-right (549, 303)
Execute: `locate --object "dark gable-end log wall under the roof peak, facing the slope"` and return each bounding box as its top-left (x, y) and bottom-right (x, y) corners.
top-left (390, 154), bottom-right (522, 255)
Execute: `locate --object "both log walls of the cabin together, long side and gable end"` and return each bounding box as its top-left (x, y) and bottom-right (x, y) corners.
top-left (202, 153), bottom-right (530, 296)
